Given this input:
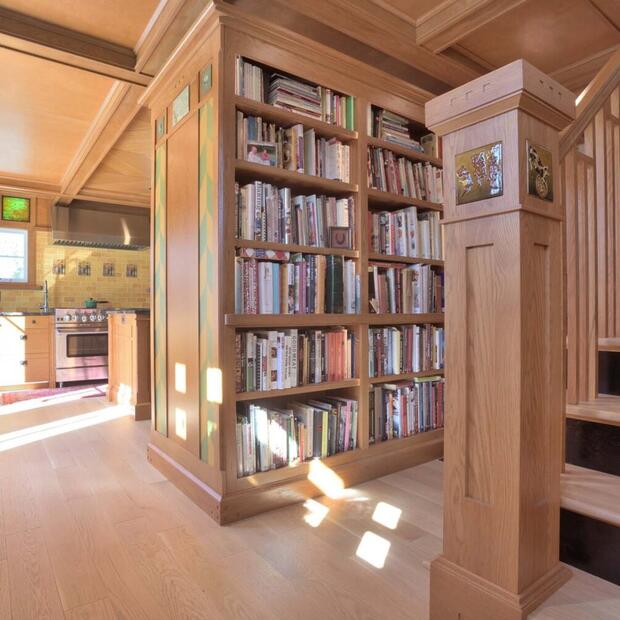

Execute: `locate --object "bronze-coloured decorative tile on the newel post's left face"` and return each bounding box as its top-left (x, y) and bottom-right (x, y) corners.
top-left (455, 142), bottom-right (504, 205)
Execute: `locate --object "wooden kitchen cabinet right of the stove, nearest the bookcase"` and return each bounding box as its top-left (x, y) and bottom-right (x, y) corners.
top-left (108, 312), bottom-right (151, 420)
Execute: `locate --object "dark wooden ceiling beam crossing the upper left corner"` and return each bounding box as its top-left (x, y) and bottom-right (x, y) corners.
top-left (0, 7), bottom-right (151, 86)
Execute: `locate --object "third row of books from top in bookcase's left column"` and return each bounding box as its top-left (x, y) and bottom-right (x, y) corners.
top-left (235, 181), bottom-right (355, 249)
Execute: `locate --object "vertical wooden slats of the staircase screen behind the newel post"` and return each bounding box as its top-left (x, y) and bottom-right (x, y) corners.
top-left (562, 83), bottom-right (620, 403)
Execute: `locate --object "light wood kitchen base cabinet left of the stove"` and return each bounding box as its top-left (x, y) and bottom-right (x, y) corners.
top-left (0, 315), bottom-right (55, 389)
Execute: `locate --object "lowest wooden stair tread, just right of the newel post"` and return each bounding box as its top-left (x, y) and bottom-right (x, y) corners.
top-left (561, 463), bottom-right (620, 527)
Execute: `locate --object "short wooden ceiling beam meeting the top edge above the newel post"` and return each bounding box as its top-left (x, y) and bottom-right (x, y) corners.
top-left (416, 0), bottom-right (525, 54)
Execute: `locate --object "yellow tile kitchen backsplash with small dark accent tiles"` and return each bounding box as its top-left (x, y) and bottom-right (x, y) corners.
top-left (0, 230), bottom-right (150, 312)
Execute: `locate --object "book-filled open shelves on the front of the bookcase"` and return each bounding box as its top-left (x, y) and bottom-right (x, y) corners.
top-left (227, 57), bottom-right (444, 480)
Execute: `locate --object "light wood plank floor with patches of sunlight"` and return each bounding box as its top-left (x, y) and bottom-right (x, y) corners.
top-left (0, 398), bottom-right (620, 620)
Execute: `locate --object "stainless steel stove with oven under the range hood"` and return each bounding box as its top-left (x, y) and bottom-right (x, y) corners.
top-left (54, 308), bottom-right (108, 385)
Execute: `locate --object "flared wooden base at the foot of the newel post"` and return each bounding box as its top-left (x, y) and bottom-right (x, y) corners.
top-left (429, 556), bottom-right (571, 620)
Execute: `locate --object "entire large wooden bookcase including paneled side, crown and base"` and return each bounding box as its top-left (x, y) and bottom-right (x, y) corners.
top-left (146, 12), bottom-right (443, 522)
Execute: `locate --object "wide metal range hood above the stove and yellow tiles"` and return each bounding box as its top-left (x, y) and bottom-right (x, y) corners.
top-left (52, 200), bottom-right (150, 250)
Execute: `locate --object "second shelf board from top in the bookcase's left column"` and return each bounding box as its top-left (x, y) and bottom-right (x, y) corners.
top-left (235, 159), bottom-right (357, 196)
